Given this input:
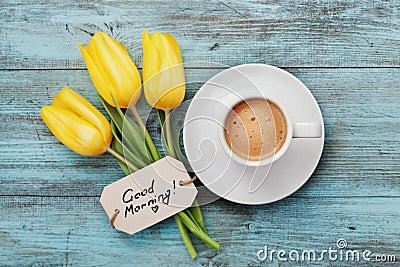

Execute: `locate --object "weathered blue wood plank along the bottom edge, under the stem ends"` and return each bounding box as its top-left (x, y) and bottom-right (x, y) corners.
top-left (0, 197), bottom-right (400, 266)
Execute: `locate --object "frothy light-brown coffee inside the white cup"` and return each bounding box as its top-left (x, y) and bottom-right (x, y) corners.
top-left (224, 98), bottom-right (287, 161)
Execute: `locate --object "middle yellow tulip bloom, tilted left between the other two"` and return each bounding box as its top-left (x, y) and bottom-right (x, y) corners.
top-left (78, 32), bottom-right (141, 108)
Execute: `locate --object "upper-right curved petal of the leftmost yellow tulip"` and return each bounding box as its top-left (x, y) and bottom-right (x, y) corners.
top-left (52, 88), bottom-right (112, 147)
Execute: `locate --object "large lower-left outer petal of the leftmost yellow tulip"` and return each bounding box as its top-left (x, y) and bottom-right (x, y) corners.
top-left (40, 106), bottom-right (109, 156)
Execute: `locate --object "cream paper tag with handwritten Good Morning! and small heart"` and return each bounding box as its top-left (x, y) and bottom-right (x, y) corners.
top-left (100, 157), bottom-right (197, 234)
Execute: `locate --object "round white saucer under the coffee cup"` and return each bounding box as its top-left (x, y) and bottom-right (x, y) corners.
top-left (183, 64), bottom-right (324, 205)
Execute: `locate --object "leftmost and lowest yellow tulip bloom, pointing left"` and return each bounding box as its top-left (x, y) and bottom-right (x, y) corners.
top-left (40, 88), bottom-right (112, 156)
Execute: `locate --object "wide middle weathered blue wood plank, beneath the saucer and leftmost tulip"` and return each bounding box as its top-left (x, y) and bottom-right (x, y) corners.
top-left (0, 69), bottom-right (400, 196)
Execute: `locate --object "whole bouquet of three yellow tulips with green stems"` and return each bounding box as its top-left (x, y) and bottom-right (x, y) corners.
top-left (41, 31), bottom-right (219, 258)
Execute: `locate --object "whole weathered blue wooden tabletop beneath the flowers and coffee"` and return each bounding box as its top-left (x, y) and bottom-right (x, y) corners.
top-left (0, 0), bottom-right (400, 266)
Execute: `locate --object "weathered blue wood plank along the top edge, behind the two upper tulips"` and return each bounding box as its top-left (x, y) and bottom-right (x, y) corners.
top-left (0, 0), bottom-right (400, 69)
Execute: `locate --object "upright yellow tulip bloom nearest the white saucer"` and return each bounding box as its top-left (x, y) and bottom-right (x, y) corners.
top-left (142, 30), bottom-right (186, 110)
